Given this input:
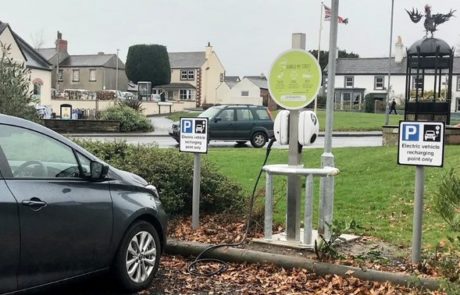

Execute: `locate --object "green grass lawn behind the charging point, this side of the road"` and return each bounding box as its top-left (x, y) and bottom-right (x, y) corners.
top-left (204, 146), bottom-right (460, 247)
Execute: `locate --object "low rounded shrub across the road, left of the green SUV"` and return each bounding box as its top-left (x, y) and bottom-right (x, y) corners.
top-left (100, 105), bottom-right (153, 132)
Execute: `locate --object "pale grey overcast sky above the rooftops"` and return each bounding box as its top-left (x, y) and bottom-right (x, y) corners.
top-left (0, 0), bottom-right (460, 76)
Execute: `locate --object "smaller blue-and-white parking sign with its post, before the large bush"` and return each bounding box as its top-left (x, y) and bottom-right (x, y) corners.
top-left (179, 118), bottom-right (208, 229)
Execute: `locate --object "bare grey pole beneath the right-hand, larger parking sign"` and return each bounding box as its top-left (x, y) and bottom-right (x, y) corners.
top-left (412, 166), bottom-right (425, 264)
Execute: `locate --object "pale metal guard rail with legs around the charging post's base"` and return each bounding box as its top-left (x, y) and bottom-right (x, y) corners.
top-left (262, 164), bottom-right (340, 249)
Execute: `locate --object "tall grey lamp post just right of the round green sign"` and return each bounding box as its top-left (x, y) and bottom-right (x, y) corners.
top-left (318, 0), bottom-right (339, 239)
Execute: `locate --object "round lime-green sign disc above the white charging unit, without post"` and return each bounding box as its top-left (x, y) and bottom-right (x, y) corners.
top-left (268, 49), bottom-right (322, 110)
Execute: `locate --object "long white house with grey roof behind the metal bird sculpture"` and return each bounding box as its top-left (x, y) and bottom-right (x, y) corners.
top-left (335, 39), bottom-right (460, 112)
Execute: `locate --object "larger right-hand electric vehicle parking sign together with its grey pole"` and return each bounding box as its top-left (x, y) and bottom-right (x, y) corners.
top-left (398, 121), bottom-right (444, 264)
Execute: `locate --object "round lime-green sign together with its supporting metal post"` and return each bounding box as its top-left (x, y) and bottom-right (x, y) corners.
top-left (268, 46), bottom-right (322, 240)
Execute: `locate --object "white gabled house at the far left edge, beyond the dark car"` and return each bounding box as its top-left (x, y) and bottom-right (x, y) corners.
top-left (0, 21), bottom-right (51, 105)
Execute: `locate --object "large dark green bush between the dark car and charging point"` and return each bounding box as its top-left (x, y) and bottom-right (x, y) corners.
top-left (79, 142), bottom-right (244, 215)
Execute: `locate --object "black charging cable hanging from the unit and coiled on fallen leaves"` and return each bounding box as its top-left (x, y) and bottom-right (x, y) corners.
top-left (188, 138), bottom-right (276, 276)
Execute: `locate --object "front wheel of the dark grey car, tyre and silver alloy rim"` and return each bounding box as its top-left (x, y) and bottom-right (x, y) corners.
top-left (114, 221), bottom-right (161, 292)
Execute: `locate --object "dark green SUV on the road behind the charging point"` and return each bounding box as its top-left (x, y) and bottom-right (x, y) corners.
top-left (169, 105), bottom-right (273, 148)
